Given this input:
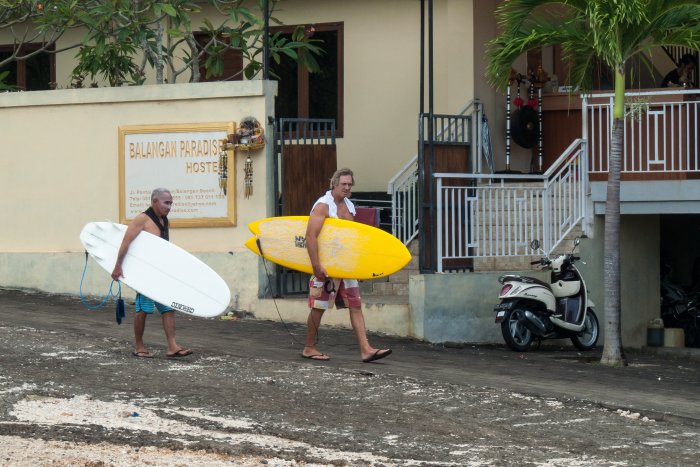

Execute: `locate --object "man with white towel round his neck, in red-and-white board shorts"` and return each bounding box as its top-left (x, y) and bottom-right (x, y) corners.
top-left (301, 169), bottom-right (391, 363)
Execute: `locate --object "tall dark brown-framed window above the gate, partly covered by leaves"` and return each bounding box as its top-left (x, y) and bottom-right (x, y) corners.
top-left (270, 23), bottom-right (343, 137)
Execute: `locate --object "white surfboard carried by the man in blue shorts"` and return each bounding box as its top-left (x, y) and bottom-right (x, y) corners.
top-left (80, 222), bottom-right (231, 318)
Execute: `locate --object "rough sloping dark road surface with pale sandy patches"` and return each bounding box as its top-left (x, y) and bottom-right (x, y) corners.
top-left (0, 290), bottom-right (700, 466)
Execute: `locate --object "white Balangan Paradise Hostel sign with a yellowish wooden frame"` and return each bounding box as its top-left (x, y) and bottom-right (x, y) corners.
top-left (119, 122), bottom-right (236, 227)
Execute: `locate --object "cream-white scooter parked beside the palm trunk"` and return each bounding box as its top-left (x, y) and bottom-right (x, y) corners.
top-left (494, 237), bottom-right (600, 352)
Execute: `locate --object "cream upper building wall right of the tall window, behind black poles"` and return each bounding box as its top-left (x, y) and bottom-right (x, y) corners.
top-left (0, 0), bottom-right (482, 191)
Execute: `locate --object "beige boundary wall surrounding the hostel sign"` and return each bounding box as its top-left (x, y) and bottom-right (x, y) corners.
top-left (0, 81), bottom-right (276, 310)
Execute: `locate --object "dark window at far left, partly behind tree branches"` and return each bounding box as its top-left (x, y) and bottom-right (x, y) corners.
top-left (0, 44), bottom-right (56, 91)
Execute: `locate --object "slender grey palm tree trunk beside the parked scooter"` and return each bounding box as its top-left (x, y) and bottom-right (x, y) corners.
top-left (601, 71), bottom-right (627, 366)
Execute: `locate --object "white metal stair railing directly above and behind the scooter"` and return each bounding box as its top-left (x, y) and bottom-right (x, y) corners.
top-left (434, 139), bottom-right (588, 272)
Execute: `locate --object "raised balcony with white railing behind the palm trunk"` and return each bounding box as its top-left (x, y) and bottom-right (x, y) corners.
top-left (543, 89), bottom-right (700, 214)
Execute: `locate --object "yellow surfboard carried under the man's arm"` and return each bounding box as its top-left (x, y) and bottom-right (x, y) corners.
top-left (245, 216), bottom-right (411, 279)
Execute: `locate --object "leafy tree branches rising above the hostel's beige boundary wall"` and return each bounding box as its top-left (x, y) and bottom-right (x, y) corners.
top-left (0, 0), bottom-right (322, 86)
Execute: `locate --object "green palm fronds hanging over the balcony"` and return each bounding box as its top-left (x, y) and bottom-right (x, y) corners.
top-left (487, 0), bottom-right (700, 98)
